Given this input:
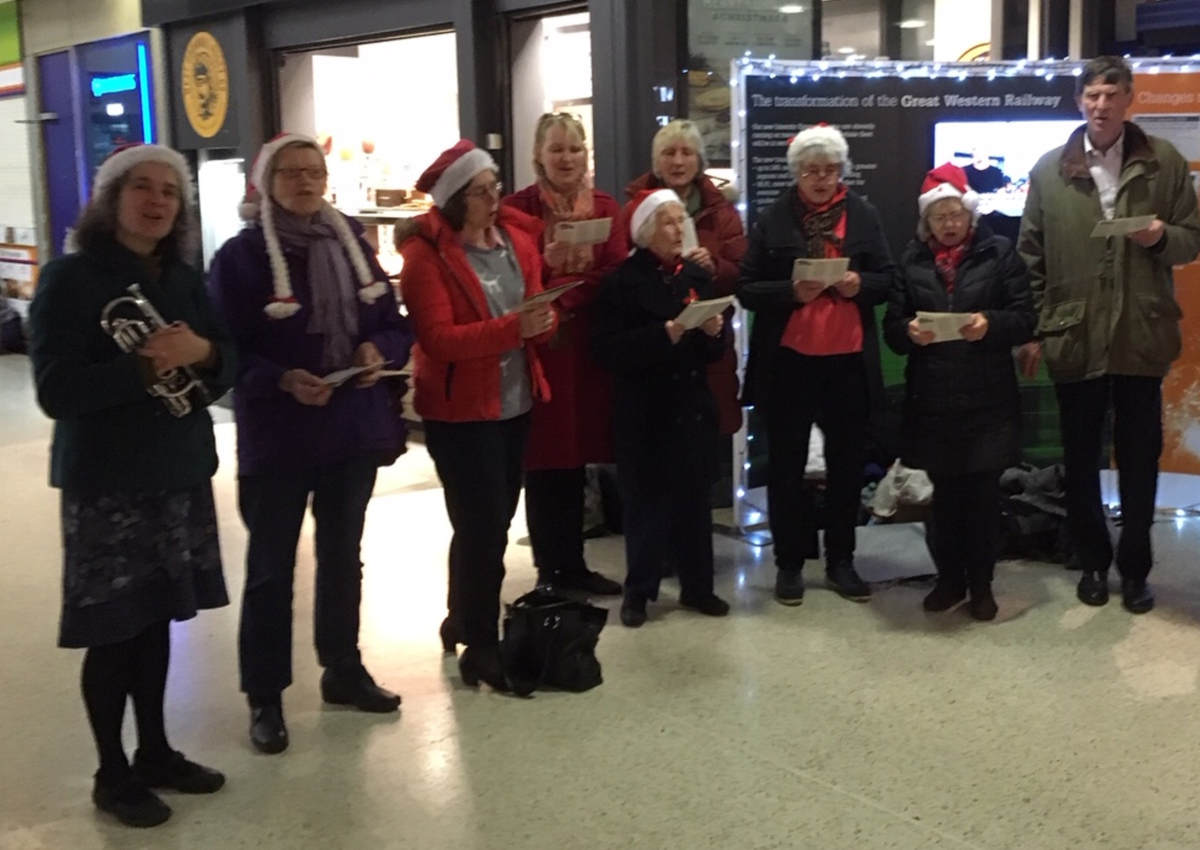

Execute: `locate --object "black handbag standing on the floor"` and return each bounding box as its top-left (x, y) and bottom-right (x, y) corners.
top-left (500, 587), bottom-right (608, 696)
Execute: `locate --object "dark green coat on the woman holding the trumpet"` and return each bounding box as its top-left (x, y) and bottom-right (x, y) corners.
top-left (29, 243), bottom-right (235, 492)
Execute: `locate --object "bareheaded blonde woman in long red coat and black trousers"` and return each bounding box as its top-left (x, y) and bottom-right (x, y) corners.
top-left (500, 113), bottom-right (629, 594)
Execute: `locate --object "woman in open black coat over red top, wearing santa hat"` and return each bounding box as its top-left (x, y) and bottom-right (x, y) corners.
top-left (738, 126), bottom-right (892, 605)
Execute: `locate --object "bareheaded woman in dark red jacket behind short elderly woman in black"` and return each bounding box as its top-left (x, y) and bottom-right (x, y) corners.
top-left (625, 119), bottom-right (746, 437)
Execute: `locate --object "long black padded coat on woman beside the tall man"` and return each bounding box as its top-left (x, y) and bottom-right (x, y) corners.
top-left (883, 225), bottom-right (1037, 475)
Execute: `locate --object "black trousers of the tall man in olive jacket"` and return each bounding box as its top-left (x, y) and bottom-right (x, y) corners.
top-left (1055, 375), bottom-right (1163, 580)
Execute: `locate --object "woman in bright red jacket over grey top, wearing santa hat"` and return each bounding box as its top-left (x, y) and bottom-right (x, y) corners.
top-left (396, 139), bottom-right (558, 690)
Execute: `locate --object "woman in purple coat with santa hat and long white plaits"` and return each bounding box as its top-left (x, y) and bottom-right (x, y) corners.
top-left (209, 133), bottom-right (413, 753)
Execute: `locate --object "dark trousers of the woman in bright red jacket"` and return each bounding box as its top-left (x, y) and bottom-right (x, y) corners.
top-left (425, 414), bottom-right (529, 647)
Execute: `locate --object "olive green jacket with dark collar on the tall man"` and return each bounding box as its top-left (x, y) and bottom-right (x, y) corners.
top-left (1018, 122), bottom-right (1200, 382)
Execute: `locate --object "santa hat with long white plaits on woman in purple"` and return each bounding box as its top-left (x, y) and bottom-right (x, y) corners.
top-left (239, 132), bottom-right (388, 319)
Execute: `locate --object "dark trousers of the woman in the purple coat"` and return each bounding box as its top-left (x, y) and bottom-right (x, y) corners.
top-left (238, 457), bottom-right (378, 701)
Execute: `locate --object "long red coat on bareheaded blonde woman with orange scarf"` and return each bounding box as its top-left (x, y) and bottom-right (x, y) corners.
top-left (500, 184), bottom-right (629, 469)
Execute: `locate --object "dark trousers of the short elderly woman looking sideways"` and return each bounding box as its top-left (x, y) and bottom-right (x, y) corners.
top-left (617, 433), bottom-right (715, 600)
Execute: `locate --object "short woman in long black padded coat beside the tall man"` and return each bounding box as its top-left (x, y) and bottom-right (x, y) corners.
top-left (883, 164), bottom-right (1037, 619)
